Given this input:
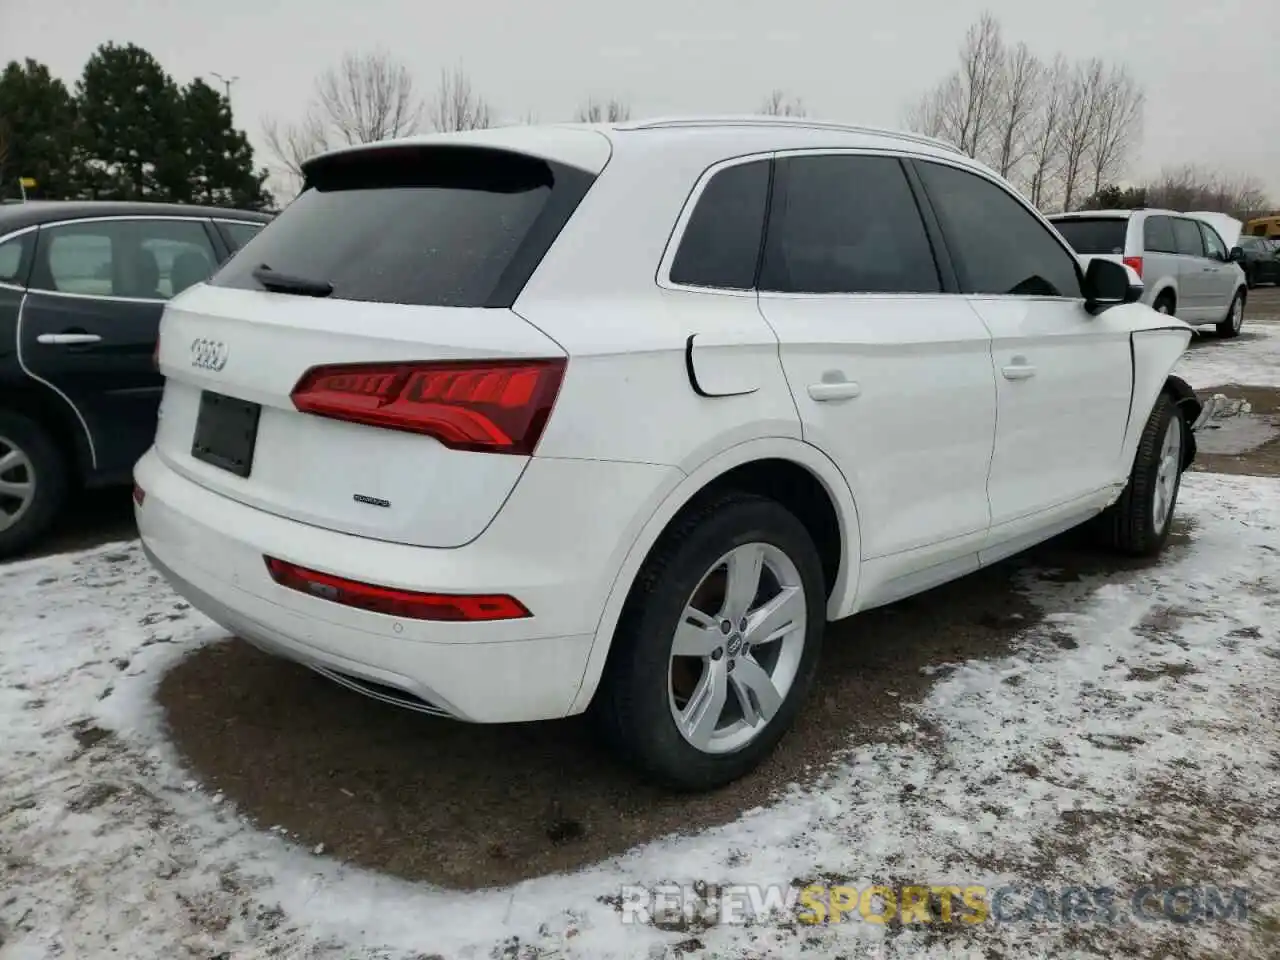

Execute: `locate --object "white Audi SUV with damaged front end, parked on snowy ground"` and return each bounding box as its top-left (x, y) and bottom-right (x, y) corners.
top-left (134, 118), bottom-right (1201, 790)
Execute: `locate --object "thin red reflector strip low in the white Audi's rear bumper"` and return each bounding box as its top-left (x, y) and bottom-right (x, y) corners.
top-left (264, 557), bottom-right (532, 622)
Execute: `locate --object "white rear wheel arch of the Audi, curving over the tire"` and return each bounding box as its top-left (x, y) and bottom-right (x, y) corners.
top-left (568, 436), bottom-right (861, 714)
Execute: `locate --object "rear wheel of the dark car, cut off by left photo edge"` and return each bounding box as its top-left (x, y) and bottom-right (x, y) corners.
top-left (0, 410), bottom-right (68, 559)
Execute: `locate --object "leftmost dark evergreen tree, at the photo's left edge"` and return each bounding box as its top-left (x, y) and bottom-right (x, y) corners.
top-left (0, 59), bottom-right (76, 198)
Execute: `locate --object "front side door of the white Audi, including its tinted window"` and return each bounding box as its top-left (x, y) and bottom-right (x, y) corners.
top-left (915, 161), bottom-right (1133, 545)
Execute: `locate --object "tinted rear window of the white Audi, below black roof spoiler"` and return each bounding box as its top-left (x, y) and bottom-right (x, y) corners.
top-left (214, 147), bottom-right (593, 307)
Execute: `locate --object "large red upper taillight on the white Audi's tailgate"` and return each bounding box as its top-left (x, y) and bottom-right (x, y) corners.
top-left (291, 358), bottom-right (564, 456)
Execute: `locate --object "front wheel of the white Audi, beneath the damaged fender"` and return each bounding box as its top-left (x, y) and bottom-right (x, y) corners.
top-left (1100, 393), bottom-right (1188, 557)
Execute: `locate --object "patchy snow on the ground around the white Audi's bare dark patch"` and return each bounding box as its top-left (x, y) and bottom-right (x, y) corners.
top-left (0, 473), bottom-right (1280, 960)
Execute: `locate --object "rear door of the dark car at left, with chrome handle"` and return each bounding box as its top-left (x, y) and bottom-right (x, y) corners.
top-left (19, 218), bottom-right (216, 483)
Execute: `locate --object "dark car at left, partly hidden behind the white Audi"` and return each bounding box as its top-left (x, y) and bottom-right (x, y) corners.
top-left (0, 201), bottom-right (270, 557)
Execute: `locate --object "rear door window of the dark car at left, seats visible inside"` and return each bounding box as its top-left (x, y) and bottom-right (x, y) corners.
top-left (31, 220), bottom-right (215, 300)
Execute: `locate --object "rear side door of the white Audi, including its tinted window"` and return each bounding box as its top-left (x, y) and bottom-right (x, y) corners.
top-left (759, 152), bottom-right (996, 568)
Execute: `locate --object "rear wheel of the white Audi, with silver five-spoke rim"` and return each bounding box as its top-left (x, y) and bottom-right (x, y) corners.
top-left (593, 493), bottom-right (827, 791)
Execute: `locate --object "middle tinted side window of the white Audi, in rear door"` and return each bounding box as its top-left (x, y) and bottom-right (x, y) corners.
top-left (760, 155), bottom-right (942, 293)
